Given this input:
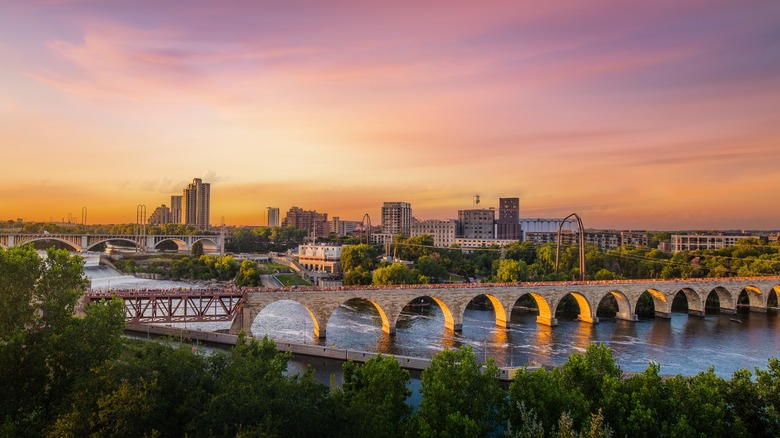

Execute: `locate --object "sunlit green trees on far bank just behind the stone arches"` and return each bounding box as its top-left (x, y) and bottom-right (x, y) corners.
top-left (341, 236), bottom-right (780, 284)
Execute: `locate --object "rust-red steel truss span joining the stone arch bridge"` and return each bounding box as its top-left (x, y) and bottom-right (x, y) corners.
top-left (84, 289), bottom-right (246, 323)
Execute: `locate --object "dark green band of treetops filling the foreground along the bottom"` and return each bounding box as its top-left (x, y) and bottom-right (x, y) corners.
top-left (0, 246), bottom-right (780, 437)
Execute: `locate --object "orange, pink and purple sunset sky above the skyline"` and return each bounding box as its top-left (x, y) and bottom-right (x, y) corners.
top-left (0, 0), bottom-right (780, 230)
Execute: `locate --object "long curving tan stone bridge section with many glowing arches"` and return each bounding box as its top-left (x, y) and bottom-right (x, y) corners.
top-left (230, 277), bottom-right (780, 338)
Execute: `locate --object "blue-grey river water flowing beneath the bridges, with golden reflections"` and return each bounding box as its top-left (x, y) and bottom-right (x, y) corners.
top-left (85, 263), bottom-right (780, 381)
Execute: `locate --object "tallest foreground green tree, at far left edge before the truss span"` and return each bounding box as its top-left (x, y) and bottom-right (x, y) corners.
top-left (0, 247), bottom-right (124, 436)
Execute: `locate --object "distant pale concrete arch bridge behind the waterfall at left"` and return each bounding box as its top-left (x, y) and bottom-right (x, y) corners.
top-left (0, 233), bottom-right (224, 252)
